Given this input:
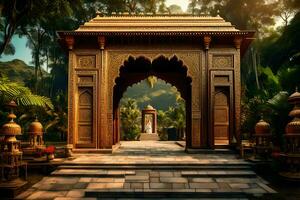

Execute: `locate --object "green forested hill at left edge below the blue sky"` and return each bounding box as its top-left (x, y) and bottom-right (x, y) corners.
top-left (0, 59), bottom-right (34, 83)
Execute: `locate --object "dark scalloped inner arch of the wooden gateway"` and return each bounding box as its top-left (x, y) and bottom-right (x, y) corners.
top-left (113, 56), bottom-right (192, 147)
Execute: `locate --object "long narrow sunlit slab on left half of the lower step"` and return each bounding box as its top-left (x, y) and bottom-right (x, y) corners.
top-left (51, 169), bottom-right (135, 177)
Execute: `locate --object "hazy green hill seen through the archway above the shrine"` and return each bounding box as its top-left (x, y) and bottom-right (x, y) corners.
top-left (121, 79), bottom-right (179, 111)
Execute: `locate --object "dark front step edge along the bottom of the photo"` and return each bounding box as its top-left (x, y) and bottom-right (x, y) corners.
top-left (85, 189), bottom-right (274, 199)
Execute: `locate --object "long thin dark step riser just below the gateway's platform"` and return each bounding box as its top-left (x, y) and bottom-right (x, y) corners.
top-left (58, 165), bottom-right (252, 170)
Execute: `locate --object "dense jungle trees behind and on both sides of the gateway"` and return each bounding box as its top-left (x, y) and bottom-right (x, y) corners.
top-left (0, 0), bottom-right (300, 143)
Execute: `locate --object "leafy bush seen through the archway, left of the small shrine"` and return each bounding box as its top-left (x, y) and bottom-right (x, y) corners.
top-left (120, 99), bottom-right (141, 140)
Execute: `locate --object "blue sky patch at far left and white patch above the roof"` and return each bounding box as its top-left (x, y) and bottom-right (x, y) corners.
top-left (0, 0), bottom-right (189, 65)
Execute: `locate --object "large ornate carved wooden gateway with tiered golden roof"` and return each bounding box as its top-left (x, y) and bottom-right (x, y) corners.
top-left (58, 15), bottom-right (254, 151)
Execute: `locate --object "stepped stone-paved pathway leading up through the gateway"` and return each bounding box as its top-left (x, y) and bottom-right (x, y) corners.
top-left (18, 141), bottom-right (276, 200)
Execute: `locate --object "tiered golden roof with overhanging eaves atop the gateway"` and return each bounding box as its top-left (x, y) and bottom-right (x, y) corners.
top-left (58, 14), bottom-right (255, 52)
